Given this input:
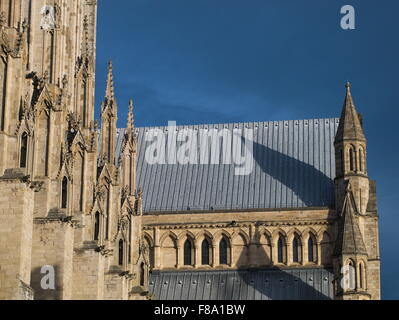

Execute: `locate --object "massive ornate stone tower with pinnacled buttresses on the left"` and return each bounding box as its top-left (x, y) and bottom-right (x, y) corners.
top-left (0, 0), bottom-right (147, 299)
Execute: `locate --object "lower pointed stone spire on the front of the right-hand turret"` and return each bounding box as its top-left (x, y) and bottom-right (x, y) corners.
top-left (334, 183), bottom-right (367, 256)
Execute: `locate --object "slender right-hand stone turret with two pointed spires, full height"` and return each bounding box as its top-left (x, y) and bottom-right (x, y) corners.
top-left (334, 83), bottom-right (380, 300)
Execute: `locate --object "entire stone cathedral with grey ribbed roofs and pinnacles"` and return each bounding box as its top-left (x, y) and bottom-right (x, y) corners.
top-left (0, 0), bottom-right (381, 300)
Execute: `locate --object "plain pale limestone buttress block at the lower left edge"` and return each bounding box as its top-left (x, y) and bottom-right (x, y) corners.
top-left (0, 172), bottom-right (34, 300)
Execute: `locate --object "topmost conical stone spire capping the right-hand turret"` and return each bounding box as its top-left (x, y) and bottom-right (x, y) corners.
top-left (335, 82), bottom-right (366, 143)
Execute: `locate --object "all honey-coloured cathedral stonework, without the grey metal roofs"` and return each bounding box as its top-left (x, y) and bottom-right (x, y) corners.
top-left (0, 0), bottom-right (380, 300)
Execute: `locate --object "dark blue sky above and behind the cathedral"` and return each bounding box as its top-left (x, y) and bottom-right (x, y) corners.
top-left (96, 0), bottom-right (399, 299)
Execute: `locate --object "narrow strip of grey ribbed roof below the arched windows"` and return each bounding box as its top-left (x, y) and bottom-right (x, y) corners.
top-left (150, 268), bottom-right (334, 300)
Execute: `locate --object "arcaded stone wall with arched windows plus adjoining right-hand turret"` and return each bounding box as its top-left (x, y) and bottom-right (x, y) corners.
top-left (143, 83), bottom-right (381, 300)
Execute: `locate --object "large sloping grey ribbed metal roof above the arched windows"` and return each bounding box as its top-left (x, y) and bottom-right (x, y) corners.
top-left (117, 119), bottom-right (339, 212)
